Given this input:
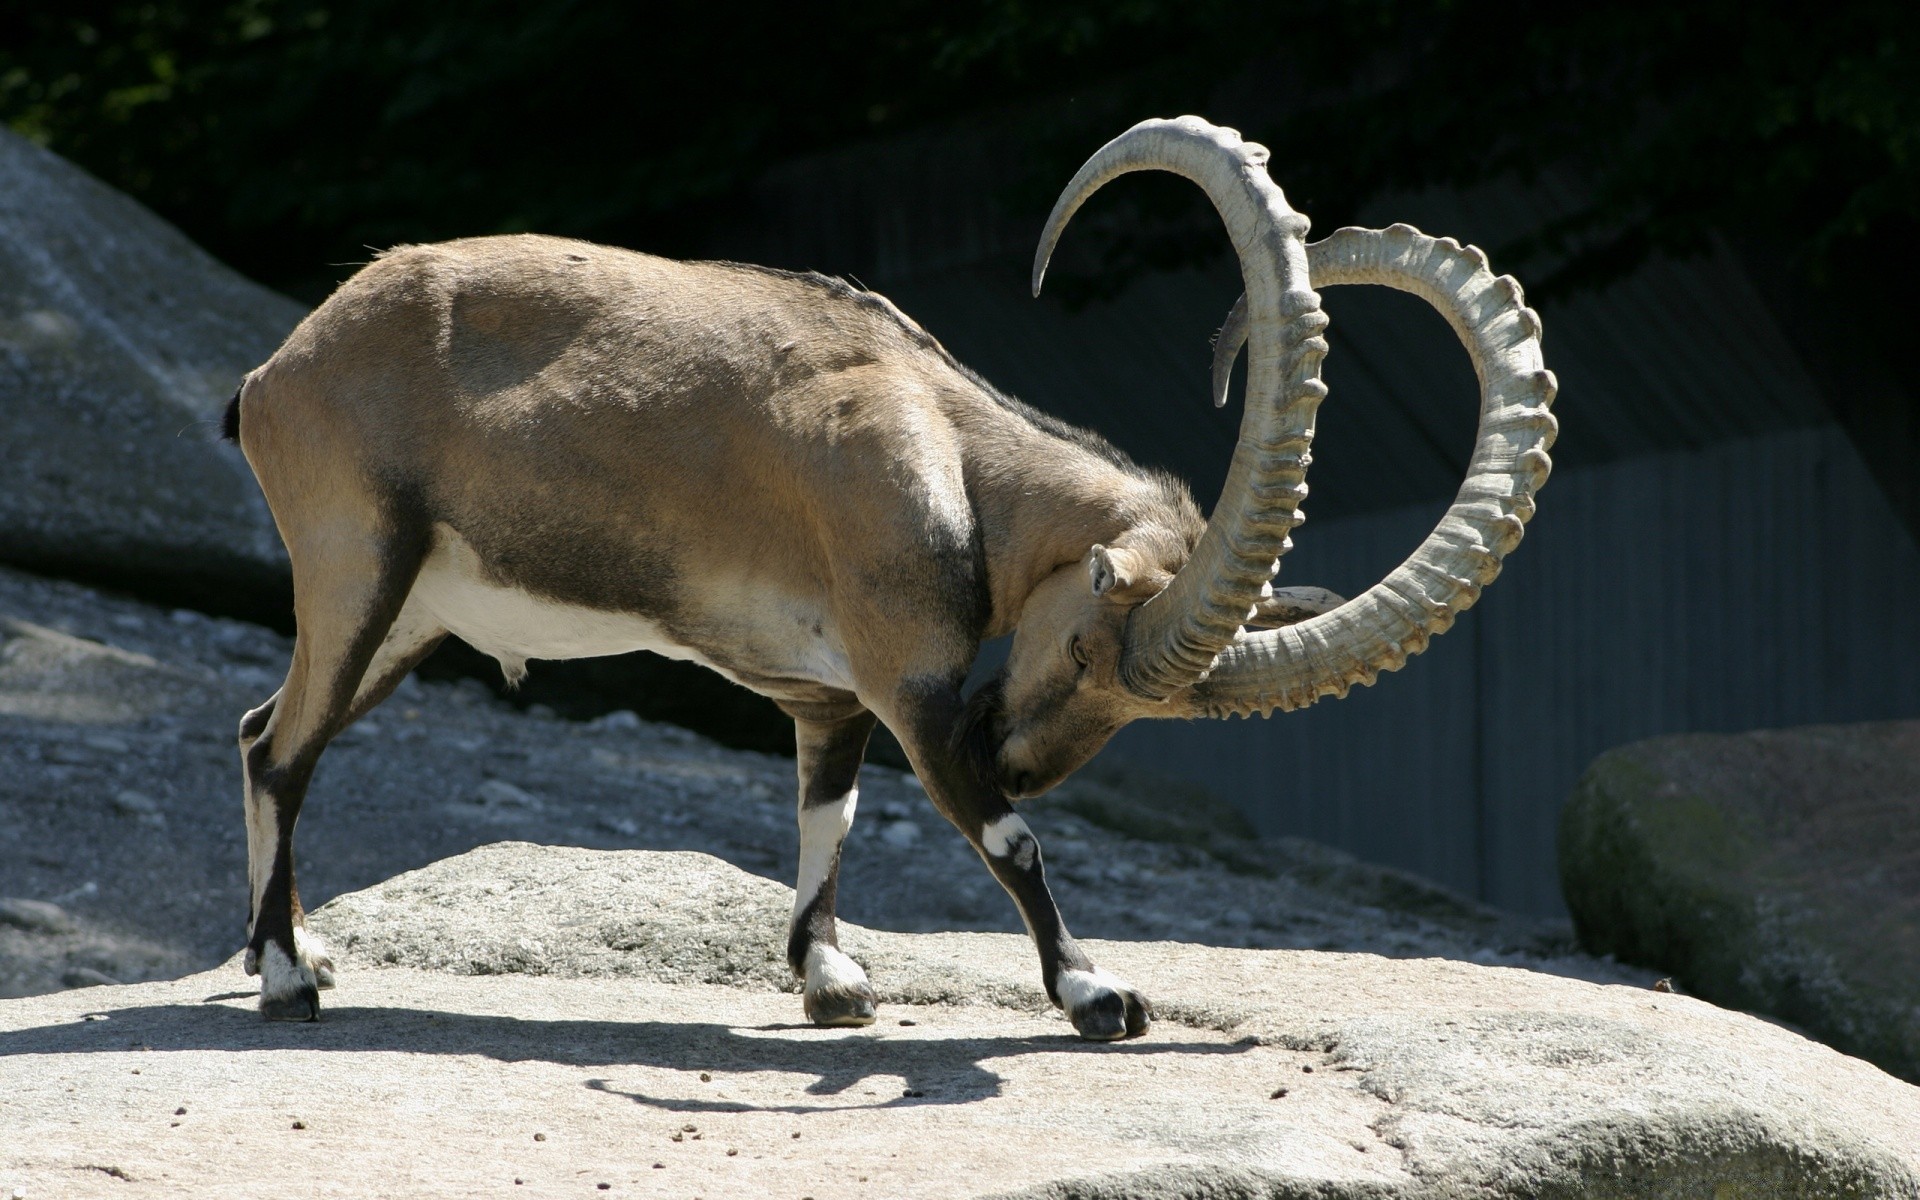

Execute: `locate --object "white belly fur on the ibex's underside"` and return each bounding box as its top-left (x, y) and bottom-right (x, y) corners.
top-left (407, 526), bottom-right (852, 689)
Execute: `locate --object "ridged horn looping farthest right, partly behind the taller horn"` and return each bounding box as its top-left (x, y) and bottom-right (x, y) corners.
top-left (1169, 225), bottom-right (1559, 716)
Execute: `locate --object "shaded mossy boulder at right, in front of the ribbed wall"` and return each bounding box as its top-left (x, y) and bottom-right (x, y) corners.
top-left (1559, 722), bottom-right (1920, 1081)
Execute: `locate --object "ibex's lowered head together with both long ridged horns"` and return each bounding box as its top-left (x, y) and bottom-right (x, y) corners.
top-left (960, 117), bottom-right (1557, 795)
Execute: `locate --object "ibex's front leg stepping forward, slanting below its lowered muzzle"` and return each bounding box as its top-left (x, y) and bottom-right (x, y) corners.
top-left (889, 685), bottom-right (1154, 1041)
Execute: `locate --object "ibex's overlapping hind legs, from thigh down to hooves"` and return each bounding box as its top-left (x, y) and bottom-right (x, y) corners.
top-left (240, 536), bottom-right (433, 1021)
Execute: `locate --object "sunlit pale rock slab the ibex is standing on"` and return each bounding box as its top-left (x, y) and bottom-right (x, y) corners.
top-left (0, 843), bottom-right (1920, 1200)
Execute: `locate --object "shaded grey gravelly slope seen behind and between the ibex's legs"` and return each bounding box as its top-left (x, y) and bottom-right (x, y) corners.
top-left (0, 570), bottom-right (1651, 996)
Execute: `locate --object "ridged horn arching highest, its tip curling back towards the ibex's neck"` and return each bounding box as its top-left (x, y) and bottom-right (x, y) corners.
top-left (1033, 117), bottom-right (1327, 701)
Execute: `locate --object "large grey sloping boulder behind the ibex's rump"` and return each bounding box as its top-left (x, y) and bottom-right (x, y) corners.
top-left (0, 127), bottom-right (303, 612)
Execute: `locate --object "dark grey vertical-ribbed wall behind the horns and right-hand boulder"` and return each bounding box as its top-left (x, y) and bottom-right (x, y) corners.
top-left (1108, 428), bottom-right (1920, 912)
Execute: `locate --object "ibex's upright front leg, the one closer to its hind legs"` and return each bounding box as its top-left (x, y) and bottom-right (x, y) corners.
top-left (787, 707), bottom-right (876, 1025)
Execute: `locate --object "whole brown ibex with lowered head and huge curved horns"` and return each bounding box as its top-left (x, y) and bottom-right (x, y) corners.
top-left (227, 117), bottom-right (1555, 1039)
